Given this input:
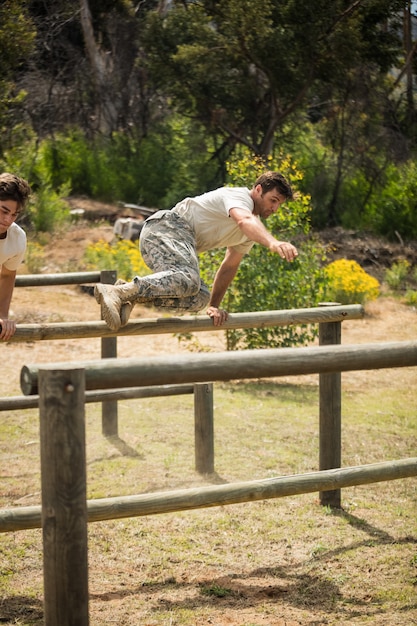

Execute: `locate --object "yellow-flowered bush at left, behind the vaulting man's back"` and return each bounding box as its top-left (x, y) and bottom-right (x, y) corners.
top-left (84, 239), bottom-right (150, 280)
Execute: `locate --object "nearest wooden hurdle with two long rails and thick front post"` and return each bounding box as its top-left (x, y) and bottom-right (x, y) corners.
top-left (4, 286), bottom-right (417, 626)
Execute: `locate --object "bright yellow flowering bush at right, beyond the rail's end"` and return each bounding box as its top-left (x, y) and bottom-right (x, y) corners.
top-left (325, 259), bottom-right (380, 304)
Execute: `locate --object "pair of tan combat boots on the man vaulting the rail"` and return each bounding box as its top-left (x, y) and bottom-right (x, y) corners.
top-left (94, 282), bottom-right (139, 330)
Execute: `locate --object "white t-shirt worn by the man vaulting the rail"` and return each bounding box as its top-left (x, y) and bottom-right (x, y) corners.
top-left (172, 187), bottom-right (254, 254)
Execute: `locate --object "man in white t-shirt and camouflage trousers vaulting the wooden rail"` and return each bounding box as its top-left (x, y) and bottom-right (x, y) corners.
top-left (94, 172), bottom-right (298, 330)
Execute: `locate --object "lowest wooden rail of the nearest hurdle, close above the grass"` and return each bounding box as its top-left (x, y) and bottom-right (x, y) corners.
top-left (0, 457), bottom-right (417, 532)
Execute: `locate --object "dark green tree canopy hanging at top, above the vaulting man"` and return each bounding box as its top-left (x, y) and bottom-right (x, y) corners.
top-left (144, 0), bottom-right (401, 156)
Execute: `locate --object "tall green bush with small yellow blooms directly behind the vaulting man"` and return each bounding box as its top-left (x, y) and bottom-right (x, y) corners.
top-left (201, 149), bottom-right (325, 350)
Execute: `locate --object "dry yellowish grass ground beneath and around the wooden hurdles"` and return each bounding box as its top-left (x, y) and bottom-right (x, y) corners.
top-left (0, 282), bottom-right (417, 626)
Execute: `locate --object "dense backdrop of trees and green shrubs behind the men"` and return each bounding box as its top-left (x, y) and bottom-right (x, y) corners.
top-left (0, 0), bottom-right (417, 239)
